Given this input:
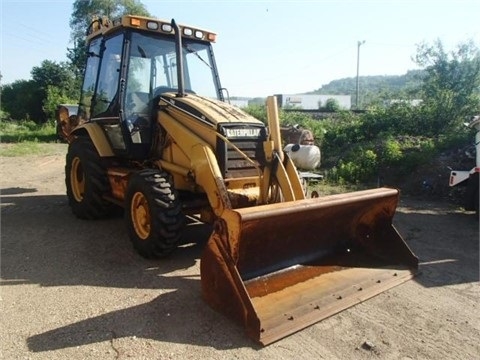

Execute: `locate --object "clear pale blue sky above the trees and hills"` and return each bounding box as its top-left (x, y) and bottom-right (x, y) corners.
top-left (0, 0), bottom-right (480, 97)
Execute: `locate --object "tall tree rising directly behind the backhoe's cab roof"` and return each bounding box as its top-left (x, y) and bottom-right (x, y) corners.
top-left (67, 0), bottom-right (150, 76)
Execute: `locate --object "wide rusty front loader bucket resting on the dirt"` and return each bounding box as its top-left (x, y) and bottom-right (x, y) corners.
top-left (201, 188), bottom-right (418, 345)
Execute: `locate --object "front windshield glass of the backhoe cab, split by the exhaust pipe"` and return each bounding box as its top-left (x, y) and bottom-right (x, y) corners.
top-left (127, 33), bottom-right (218, 101)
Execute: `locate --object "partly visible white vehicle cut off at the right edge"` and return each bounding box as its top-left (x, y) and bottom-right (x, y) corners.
top-left (449, 115), bottom-right (480, 216)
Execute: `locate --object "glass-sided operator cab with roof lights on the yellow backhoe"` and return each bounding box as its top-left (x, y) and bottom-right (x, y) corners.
top-left (78, 16), bottom-right (223, 159)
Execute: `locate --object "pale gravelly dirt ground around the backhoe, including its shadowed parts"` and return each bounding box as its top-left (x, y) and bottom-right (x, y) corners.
top-left (0, 144), bottom-right (480, 360)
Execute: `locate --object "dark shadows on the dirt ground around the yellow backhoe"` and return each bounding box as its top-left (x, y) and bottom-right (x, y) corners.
top-left (1, 193), bottom-right (479, 352)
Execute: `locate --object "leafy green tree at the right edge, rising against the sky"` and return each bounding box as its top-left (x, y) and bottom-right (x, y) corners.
top-left (415, 40), bottom-right (480, 134)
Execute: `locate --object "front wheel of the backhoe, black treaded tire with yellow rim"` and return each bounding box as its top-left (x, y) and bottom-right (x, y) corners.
top-left (125, 169), bottom-right (185, 258)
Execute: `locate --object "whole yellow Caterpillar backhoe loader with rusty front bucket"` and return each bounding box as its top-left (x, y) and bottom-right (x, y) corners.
top-left (58, 16), bottom-right (418, 345)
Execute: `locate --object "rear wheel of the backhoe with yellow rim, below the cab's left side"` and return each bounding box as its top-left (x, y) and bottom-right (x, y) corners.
top-left (65, 137), bottom-right (113, 219)
